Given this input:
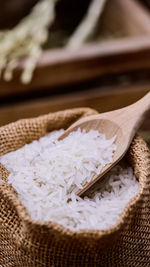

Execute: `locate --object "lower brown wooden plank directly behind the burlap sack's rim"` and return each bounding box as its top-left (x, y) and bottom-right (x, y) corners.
top-left (0, 82), bottom-right (150, 129)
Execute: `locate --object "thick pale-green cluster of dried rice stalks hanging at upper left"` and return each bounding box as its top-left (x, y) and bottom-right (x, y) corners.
top-left (0, 0), bottom-right (57, 83)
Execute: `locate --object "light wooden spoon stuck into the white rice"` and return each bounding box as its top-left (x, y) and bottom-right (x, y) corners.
top-left (59, 92), bottom-right (150, 196)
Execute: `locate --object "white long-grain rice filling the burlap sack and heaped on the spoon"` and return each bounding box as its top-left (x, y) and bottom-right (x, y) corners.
top-left (0, 129), bottom-right (139, 230)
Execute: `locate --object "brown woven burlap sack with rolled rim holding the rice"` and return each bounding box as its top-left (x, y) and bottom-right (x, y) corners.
top-left (0, 108), bottom-right (150, 267)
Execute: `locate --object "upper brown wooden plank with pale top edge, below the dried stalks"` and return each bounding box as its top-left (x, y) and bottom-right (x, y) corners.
top-left (0, 37), bottom-right (150, 97)
